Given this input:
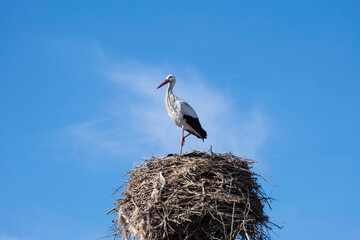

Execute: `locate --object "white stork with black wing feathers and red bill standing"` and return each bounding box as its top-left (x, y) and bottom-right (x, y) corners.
top-left (157, 75), bottom-right (207, 155)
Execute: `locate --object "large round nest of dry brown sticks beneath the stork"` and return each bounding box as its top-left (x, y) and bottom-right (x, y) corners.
top-left (109, 151), bottom-right (276, 240)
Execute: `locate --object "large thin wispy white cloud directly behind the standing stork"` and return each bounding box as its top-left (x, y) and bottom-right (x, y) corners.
top-left (65, 57), bottom-right (268, 162)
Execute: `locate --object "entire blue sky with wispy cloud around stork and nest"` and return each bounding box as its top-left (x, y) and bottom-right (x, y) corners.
top-left (0, 1), bottom-right (360, 240)
